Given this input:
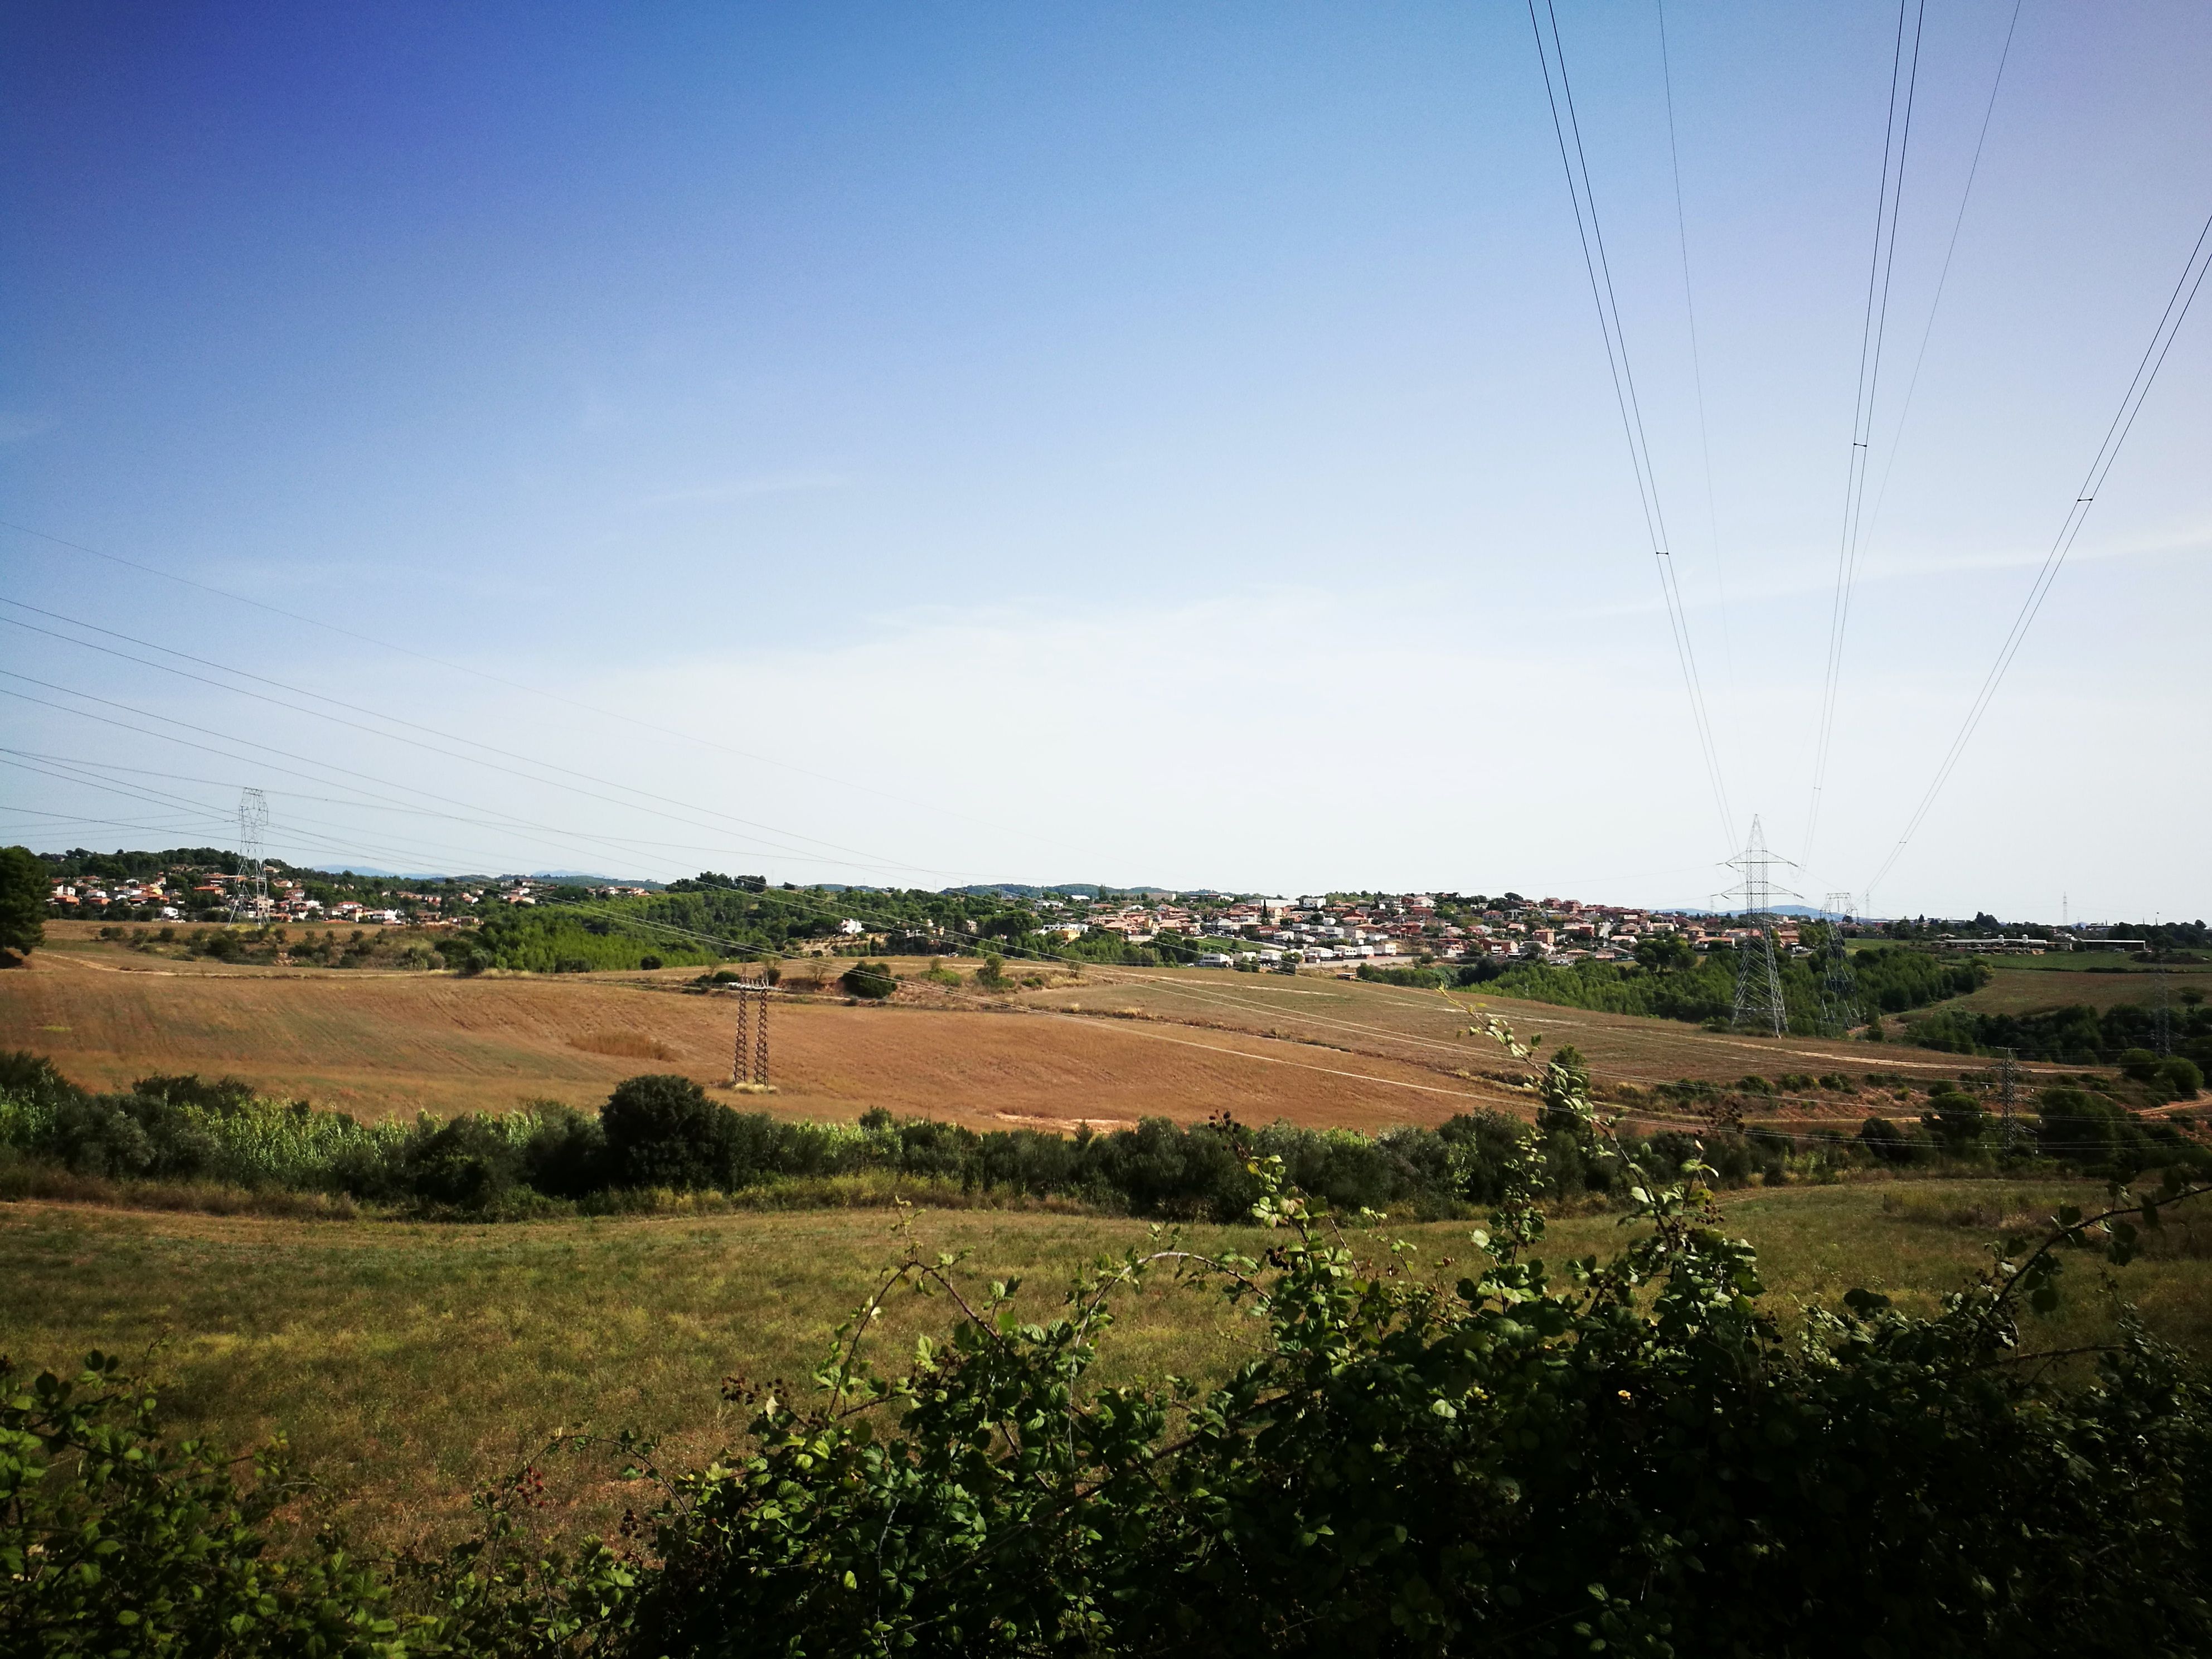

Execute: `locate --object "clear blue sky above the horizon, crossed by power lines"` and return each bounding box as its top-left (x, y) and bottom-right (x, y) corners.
top-left (0, 0), bottom-right (2212, 918)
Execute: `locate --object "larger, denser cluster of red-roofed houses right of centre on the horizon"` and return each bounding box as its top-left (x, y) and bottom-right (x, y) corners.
top-left (1037, 894), bottom-right (1805, 967)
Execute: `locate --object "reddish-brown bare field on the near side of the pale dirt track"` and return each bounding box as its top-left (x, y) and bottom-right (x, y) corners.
top-left (0, 951), bottom-right (1513, 1128)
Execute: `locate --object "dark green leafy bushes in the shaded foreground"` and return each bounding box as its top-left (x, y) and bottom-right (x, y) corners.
top-left (0, 1022), bottom-right (2212, 1655)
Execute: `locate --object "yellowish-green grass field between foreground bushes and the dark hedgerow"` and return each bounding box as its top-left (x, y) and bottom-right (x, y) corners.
top-left (0, 1181), bottom-right (2212, 1544)
